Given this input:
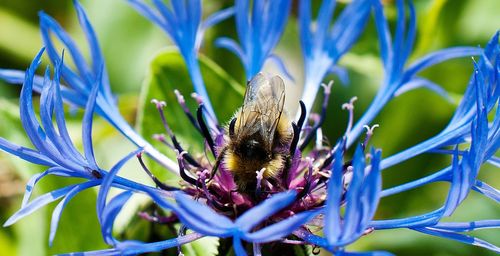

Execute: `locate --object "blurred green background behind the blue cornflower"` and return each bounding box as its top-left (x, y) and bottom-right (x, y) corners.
top-left (0, 0), bottom-right (500, 255)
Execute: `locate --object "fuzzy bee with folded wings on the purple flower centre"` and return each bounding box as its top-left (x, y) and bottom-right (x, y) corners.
top-left (221, 73), bottom-right (293, 192)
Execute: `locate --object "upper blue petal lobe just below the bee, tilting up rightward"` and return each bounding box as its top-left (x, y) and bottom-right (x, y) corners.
top-left (236, 191), bottom-right (297, 231)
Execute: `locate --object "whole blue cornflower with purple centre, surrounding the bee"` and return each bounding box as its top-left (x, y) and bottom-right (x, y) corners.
top-left (0, 0), bottom-right (500, 255)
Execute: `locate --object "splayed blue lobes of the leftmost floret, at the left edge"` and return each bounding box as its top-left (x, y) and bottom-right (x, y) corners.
top-left (0, 48), bottom-right (145, 244)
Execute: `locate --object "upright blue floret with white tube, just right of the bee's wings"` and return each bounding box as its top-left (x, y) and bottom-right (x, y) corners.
top-left (299, 0), bottom-right (371, 116)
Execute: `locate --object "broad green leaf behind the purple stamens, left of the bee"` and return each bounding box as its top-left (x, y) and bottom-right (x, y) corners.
top-left (137, 48), bottom-right (244, 180)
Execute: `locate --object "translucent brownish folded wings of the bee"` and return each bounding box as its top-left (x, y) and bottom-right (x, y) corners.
top-left (237, 73), bottom-right (285, 146)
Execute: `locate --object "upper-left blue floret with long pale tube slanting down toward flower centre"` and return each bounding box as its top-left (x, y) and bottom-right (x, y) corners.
top-left (0, 1), bottom-right (177, 172)
